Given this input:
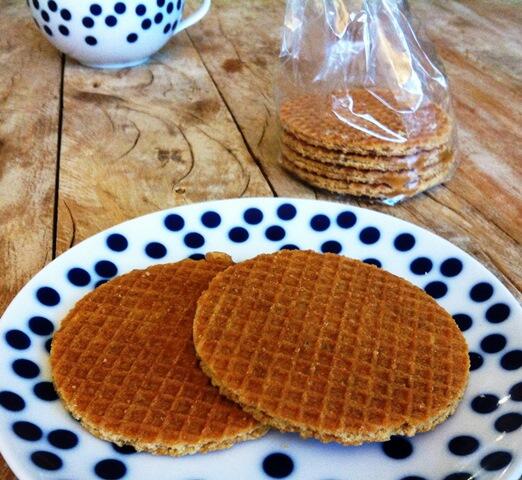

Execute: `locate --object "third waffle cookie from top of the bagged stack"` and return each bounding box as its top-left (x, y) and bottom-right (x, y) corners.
top-left (281, 145), bottom-right (447, 188)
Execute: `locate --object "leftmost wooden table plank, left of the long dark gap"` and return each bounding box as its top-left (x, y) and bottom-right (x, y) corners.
top-left (0, 0), bottom-right (61, 480)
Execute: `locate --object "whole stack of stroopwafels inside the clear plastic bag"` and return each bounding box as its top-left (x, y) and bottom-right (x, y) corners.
top-left (279, 89), bottom-right (455, 198)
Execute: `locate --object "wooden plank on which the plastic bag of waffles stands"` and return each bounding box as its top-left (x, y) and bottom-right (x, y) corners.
top-left (189, 0), bottom-right (522, 298)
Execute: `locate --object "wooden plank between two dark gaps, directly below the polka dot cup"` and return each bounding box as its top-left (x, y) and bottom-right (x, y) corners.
top-left (54, 33), bottom-right (272, 252)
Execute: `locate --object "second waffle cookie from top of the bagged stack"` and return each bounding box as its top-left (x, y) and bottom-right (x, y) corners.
top-left (281, 132), bottom-right (446, 172)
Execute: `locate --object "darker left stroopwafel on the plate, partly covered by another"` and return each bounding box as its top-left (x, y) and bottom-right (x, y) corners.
top-left (51, 254), bottom-right (266, 455)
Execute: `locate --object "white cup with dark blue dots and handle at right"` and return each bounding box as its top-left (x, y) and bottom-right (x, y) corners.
top-left (27, 0), bottom-right (211, 68)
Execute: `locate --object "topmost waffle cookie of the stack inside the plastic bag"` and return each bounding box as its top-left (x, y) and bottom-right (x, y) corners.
top-left (279, 88), bottom-right (452, 156)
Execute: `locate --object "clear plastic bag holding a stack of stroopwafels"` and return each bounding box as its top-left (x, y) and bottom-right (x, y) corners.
top-left (276, 0), bottom-right (456, 204)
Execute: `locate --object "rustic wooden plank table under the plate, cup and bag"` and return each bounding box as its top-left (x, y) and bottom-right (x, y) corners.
top-left (0, 0), bottom-right (522, 479)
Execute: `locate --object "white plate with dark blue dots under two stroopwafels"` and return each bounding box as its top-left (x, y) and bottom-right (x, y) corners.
top-left (0, 198), bottom-right (522, 480)
